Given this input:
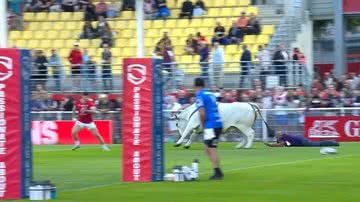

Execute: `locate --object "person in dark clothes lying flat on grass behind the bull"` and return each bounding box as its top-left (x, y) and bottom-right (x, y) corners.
top-left (264, 131), bottom-right (340, 147)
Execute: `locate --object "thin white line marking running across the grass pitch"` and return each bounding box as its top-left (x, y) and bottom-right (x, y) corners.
top-left (62, 154), bottom-right (359, 192)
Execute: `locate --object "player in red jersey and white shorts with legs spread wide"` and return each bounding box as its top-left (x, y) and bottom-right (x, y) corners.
top-left (71, 92), bottom-right (110, 151)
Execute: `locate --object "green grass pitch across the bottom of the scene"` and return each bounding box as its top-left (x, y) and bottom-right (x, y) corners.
top-left (20, 143), bottom-right (360, 202)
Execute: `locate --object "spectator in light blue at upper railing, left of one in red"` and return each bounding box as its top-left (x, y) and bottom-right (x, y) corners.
top-left (49, 49), bottom-right (64, 91)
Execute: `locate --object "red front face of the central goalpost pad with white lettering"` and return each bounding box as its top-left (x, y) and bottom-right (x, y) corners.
top-left (122, 58), bottom-right (153, 182)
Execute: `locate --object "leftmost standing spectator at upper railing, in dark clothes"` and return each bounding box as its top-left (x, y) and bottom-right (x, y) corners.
top-left (31, 50), bottom-right (49, 90)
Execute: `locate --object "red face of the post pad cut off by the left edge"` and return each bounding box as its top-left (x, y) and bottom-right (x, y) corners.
top-left (0, 49), bottom-right (22, 200)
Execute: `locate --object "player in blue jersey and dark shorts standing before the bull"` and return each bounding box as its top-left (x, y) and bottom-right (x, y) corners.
top-left (195, 78), bottom-right (224, 180)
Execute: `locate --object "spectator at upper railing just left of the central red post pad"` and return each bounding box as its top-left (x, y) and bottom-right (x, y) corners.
top-left (101, 44), bottom-right (113, 90)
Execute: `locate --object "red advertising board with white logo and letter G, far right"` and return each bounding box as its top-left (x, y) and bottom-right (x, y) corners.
top-left (305, 116), bottom-right (360, 142)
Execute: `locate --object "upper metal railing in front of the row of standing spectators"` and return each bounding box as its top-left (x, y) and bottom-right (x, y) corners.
top-left (31, 61), bottom-right (309, 92)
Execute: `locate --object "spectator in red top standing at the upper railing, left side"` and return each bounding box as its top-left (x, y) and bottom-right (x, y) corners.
top-left (68, 42), bottom-right (82, 88)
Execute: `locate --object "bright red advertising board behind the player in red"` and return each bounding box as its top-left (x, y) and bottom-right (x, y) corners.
top-left (31, 121), bottom-right (112, 145)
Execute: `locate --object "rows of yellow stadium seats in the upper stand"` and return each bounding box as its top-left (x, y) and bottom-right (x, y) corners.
top-left (9, 0), bottom-right (275, 74)
